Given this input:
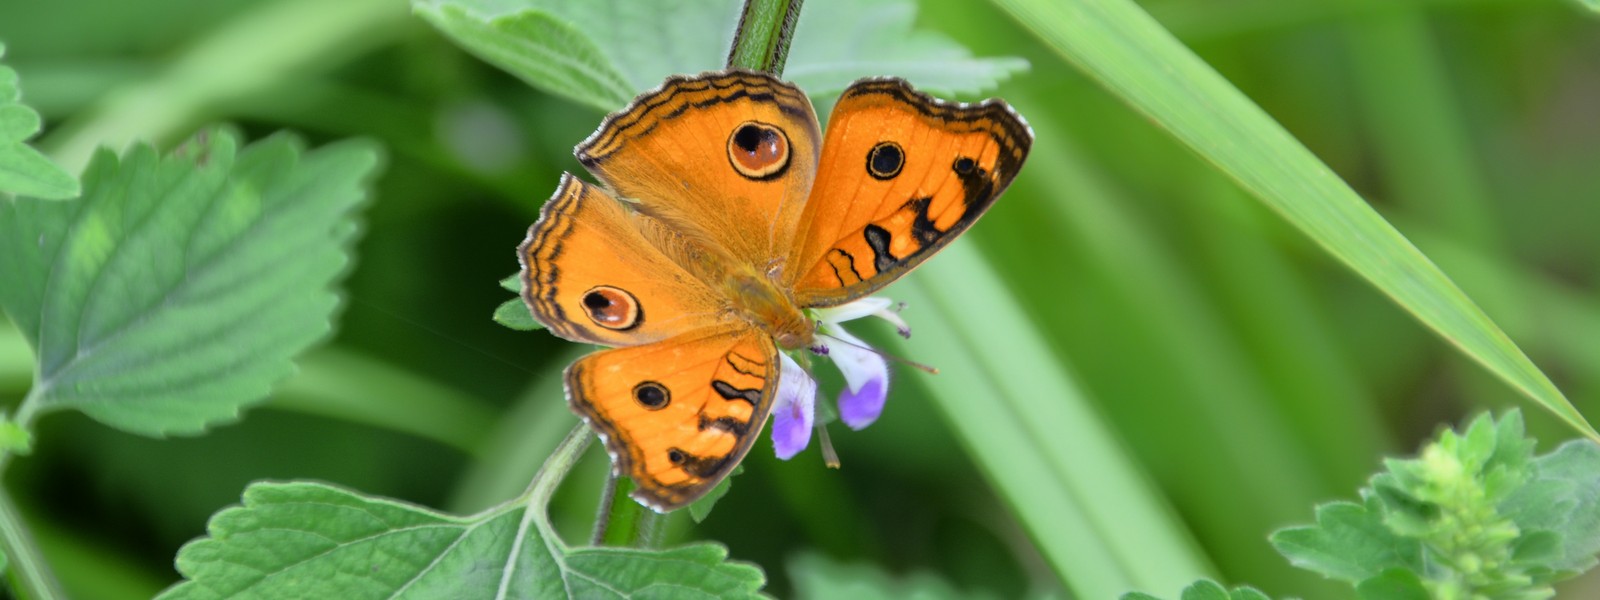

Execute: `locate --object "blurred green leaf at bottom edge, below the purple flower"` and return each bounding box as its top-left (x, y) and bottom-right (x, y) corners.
top-left (789, 552), bottom-right (987, 600)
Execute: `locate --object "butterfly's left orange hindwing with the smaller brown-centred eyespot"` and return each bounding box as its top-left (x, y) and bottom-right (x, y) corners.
top-left (517, 174), bottom-right (726, 346)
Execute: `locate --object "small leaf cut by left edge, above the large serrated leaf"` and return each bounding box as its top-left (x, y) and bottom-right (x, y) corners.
top-left (0, 43), bottom-right (78, 200)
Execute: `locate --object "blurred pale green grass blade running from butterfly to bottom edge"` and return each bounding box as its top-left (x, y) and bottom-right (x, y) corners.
top-left (894, 245), bottom-right (1210, 598)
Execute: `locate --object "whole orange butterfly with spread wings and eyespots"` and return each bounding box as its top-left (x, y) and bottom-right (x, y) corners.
top-left (517, 69), bottom-right (1034, 512)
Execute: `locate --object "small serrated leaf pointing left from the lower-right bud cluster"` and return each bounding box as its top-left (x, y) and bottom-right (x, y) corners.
top-left (1270, 498), bottom-right (1422, 584)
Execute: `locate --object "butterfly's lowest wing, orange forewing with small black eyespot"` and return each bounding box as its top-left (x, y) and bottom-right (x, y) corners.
top-left (566, 326), bottom-right (779, 512)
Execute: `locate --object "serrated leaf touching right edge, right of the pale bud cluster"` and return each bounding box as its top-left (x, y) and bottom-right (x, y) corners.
top-left (1499, 440), bottom-right (1600, 571)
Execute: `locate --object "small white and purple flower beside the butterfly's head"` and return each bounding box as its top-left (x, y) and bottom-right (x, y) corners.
top-left (773, 298), bottom-right (910, 461)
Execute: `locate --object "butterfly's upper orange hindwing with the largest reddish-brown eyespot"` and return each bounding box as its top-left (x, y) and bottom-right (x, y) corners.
top-left (576, 70), bottom-right (821, 266)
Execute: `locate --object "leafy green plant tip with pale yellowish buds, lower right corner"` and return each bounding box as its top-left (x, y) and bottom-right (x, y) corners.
top-left (1272, 411), bottom-right (1600, 600)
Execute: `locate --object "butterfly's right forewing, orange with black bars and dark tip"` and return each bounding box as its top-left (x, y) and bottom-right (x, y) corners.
top-left (787, 78), bottom-right (1034, 307)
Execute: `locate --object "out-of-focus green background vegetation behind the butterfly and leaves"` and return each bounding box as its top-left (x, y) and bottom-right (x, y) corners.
top-left (0, 0), bottom-right (1600, 598)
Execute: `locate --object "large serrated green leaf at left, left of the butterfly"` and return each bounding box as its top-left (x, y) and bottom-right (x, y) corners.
top-left (0, 133), bottom-right (378, 435)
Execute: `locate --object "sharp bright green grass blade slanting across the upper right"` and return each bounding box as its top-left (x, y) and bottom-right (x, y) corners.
top-left (995, 0), bottom-right (1600, 440)
